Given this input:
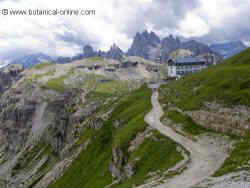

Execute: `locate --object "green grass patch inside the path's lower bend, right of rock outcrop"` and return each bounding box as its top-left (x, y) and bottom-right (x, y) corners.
top-left (117, 131), bottom-right (183, 188)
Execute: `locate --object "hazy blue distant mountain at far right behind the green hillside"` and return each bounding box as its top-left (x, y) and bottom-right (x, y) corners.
top-left (210, 41), bottom-right (247, 59)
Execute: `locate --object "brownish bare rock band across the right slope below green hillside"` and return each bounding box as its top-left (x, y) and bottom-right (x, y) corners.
top-left (187, 103), bottom-right (250, 136)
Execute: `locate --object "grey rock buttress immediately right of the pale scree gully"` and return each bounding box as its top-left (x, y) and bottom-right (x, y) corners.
top-left (39, 89), bottom-right (87, 155)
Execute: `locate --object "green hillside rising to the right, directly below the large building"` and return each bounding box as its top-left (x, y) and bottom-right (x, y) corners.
top-left (161, 49), bottom-right (250, 110)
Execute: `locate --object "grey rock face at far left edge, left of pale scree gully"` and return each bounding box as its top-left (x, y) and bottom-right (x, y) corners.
top-left (0, 95), bottom-right (36, 154)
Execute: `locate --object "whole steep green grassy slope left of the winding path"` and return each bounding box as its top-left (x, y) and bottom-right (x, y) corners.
top-left (50, 87), bottom-right (182, 188)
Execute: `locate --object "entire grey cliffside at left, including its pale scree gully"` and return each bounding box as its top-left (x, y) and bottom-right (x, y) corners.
top-left (0, 84), bottom-right (90, 188)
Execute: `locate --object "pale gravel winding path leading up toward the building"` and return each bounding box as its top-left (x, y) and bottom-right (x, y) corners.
top-left (145, 91), bottom-right (227, 188)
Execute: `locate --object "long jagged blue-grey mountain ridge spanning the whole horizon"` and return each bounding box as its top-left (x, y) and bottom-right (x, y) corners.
top-left (2, 31), bottom-right (247, 68)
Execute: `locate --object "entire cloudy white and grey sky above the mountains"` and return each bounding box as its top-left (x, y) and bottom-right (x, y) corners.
top-left (0, 0), bottom-right (250, 59)
